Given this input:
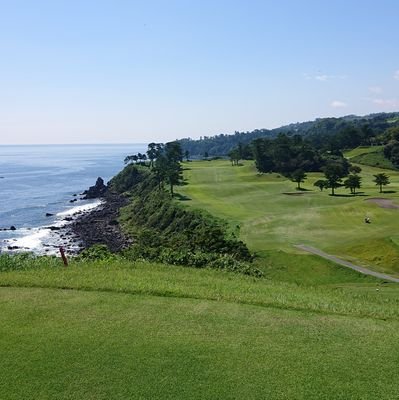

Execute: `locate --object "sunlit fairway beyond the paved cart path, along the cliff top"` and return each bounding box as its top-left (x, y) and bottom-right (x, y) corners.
top-left (179, 161), bottom-right (399, 276)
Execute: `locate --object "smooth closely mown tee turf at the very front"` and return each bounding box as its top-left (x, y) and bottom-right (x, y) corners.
top-left (0, 288), bottom-right (399, 400)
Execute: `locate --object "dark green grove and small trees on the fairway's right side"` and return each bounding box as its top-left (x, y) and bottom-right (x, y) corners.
top-left (223, 127), bottom-right (399, 195)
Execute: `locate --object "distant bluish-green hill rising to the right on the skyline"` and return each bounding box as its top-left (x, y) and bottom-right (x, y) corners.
top-left (179, 112), bottom-right (399, 157)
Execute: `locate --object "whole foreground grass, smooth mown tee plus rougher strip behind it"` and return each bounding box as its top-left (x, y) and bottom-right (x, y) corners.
top-left (0, 261), bottom-right (399, 400)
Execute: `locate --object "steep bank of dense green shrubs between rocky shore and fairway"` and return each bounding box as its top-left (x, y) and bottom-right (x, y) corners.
top-left (111, 165), bottom-right (262, 276)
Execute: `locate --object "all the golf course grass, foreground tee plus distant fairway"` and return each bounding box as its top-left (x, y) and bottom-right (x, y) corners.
top-left (0, 151), bottom-right (399, 400)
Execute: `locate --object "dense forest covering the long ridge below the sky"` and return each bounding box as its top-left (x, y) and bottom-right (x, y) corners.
top-left (179, 112), bottom-right (399, 160)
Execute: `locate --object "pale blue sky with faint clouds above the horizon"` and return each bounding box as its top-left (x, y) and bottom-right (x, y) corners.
top-left (0, 0), bottom-right (399, 144)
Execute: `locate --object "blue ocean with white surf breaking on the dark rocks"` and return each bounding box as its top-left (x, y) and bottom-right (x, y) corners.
top-left (0, 144), bottom-right (147, 254)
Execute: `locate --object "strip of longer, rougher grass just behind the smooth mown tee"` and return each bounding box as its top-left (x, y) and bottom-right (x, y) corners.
top-left (0, 256), bottom-right (399, 319)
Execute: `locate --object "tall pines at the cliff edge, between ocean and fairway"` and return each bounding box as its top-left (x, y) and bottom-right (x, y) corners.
top-left (125, 141), bottom-right (184, 196)
